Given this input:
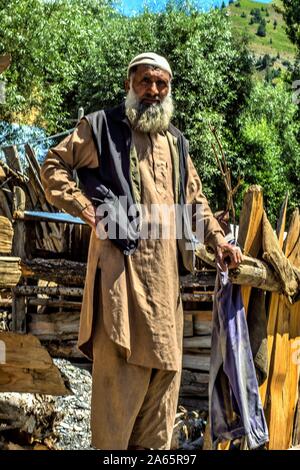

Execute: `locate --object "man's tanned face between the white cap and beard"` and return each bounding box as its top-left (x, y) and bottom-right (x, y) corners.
top-left (126, 65), bottom-right (170, 106)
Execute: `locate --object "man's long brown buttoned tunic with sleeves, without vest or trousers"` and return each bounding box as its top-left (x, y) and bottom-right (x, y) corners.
top-left (42, 116), bottom-right (224, 370)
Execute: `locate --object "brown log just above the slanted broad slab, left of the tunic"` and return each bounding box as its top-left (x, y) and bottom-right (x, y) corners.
top-left (28, 312), bottom-right (80, 340)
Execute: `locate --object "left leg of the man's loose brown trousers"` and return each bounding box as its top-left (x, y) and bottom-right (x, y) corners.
top-left (91, 326), bottom-right (151, 450)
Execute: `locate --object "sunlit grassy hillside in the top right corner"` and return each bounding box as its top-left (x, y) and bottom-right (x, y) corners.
top-left (227, 0), bottom-right (296, 62)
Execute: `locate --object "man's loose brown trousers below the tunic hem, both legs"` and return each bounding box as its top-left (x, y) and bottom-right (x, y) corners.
top-left (91, 314), bottom-right (181, 450)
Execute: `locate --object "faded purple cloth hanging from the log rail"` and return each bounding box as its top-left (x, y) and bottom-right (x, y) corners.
top-left (209, 271), bottom-right (269, 449)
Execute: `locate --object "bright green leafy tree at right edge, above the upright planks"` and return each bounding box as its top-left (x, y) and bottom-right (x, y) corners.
top-left (239, 82), bottom-right (300, 222)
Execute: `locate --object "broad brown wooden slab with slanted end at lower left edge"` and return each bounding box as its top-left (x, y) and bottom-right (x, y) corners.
top-left (0, 331), bottom-right (70, 395)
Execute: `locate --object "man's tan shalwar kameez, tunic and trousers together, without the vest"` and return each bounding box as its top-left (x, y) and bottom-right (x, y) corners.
top-left (42, 119), bottom-right (224, 449)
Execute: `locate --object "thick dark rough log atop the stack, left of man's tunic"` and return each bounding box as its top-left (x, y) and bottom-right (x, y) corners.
top-left (21, 258), bottom-right (86, 285)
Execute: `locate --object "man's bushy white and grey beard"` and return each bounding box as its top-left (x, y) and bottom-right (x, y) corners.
top-left (125, 86), bottom-right (174, 133)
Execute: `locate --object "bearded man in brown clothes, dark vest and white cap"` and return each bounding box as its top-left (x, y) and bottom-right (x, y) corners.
top-left (42, 52), bottom-right (241, 449)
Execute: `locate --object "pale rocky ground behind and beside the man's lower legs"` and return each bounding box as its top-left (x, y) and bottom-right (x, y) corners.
top-left (0, 359), bottom-right (207, 450)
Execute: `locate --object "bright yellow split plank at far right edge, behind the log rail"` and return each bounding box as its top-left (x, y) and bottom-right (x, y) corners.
top-left (262, 208), bottom-right (300, 450)
